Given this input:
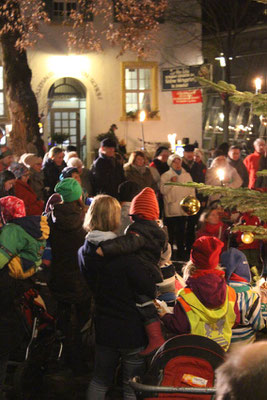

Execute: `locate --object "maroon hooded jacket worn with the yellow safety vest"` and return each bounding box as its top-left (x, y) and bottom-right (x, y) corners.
top-left (162, 271), bottom-right (240, 348)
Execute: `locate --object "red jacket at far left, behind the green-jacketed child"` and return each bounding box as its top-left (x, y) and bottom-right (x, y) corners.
top-left (14, 179), bottom-right (44, 215)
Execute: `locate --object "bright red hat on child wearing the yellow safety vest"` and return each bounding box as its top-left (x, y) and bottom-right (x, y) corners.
top-left (190, 236), bottom-right (224, 269)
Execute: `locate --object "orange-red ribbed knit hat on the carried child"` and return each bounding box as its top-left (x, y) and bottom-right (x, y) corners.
top-left (129, 187), bottom-right (159, 221)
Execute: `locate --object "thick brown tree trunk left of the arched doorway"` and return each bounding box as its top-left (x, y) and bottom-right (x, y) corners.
top-left (1, 33), bottom-right (43, 156)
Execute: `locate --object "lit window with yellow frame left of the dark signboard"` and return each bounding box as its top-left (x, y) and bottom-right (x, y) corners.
top-left (122, 62), bottom-right (158, 119)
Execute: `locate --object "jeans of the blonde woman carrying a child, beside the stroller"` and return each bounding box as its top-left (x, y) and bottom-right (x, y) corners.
top-left (87, 345), bottom-right (145, 400)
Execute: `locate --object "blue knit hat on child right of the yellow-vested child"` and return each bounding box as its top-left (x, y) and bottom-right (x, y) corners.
top-left (220, 247), bottom-right (251, 282)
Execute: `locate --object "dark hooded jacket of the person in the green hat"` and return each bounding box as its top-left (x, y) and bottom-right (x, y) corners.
top-left (49, 202), bottom-right (90, 304)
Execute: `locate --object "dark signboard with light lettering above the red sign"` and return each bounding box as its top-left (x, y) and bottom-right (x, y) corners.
top-left (161, 64), bottom-right (211, 90)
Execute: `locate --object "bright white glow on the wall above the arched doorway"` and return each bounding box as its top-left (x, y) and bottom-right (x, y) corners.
top-left (47, 55), bottom-right (90, 76)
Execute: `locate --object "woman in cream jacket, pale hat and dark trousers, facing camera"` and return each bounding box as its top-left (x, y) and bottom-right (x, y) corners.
top-left (160, 154), bottom-right (195, 257)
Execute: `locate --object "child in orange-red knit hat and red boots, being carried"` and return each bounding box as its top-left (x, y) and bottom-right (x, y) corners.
top-left (97, 187), bottom-right (167, 356)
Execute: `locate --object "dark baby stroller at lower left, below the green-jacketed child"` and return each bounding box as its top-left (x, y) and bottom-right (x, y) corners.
top-left (10, 289), bottom-right (63, 400)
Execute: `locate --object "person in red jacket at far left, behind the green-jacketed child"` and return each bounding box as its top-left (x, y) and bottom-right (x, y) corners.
top-left (9, 162), bottom-right (44, 216)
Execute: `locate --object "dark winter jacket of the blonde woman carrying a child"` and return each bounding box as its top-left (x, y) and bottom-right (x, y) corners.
top-left (78, 240), bottom-right (156, 349)
